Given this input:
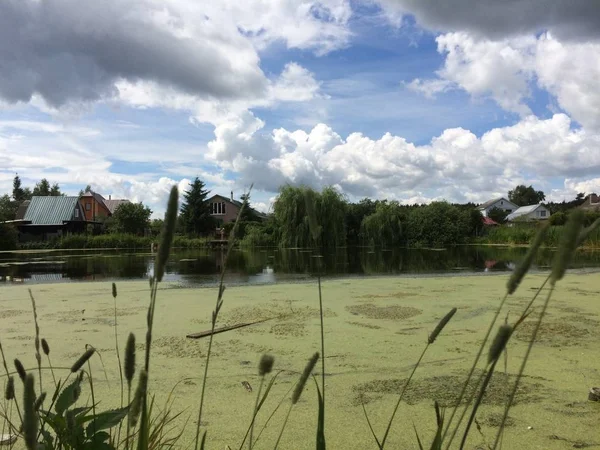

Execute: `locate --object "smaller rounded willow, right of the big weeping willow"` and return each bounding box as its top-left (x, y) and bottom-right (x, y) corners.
top-left (361, 201), bottom-right (406, 248)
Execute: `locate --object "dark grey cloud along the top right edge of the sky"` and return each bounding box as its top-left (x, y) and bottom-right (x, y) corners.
top-left (376, 0), bottom-right (600, 40)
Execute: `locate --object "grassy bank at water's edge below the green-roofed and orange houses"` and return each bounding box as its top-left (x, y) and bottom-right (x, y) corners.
top-left (18, 233), bottom-right (208, 250)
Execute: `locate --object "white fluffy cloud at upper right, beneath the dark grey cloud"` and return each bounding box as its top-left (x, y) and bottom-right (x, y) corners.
top-left (406, 32), bottom-right (600, 130)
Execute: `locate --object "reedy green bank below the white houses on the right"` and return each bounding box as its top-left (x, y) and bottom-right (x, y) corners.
top-left (475, 225), bottom-right (600, 248)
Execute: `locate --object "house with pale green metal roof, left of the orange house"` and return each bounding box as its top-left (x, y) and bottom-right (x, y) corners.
top-left (13, 196), bottom-right (87, 240)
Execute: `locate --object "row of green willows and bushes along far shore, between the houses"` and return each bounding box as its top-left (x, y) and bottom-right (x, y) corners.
top-left (242, 185), bottom-right (482, 249)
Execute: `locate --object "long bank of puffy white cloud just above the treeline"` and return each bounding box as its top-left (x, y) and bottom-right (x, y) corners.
top-left (208, 113), bottom-right (600, 201)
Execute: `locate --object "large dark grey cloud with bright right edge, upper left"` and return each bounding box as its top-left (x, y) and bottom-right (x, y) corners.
top-left (0, 0), bottom-right (267, 106)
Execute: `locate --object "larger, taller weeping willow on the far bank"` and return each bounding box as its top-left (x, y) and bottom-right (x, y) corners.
top-left (273, 185), bottom-right (346, 248)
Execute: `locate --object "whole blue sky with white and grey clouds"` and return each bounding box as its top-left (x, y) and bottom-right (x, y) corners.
top-left (0, 0), bottom-right (600, 217)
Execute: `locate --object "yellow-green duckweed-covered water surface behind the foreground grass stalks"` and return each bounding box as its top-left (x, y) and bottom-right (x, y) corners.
top-left (0, 274), bottom-right (600, 450)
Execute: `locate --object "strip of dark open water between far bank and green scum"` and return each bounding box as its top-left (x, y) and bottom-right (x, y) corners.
top-left (0, 246), bottom-right (600, 286)
